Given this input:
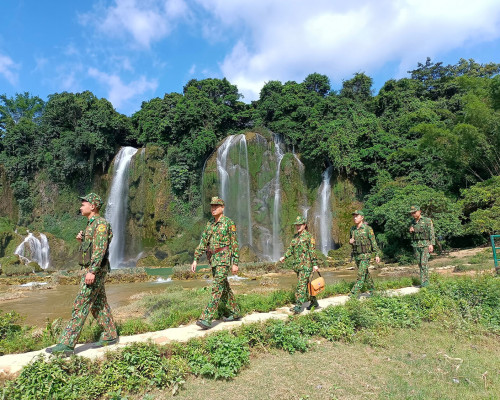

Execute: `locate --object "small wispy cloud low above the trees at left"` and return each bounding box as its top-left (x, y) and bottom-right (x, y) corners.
top-left (88, 68), bottom-right (158, 109)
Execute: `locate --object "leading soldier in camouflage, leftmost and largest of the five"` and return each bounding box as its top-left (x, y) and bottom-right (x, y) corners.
top-left (49, 193), bottom-right (118, 356)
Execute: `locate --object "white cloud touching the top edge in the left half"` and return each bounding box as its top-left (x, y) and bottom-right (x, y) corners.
top-left (80, 0), bottom-right (189, 48)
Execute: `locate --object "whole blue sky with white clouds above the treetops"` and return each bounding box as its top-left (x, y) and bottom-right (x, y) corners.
top-left (0, 0), bottom-right (500, 115)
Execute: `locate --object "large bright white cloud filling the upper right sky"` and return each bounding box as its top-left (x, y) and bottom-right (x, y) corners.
top-left (197, 0), bottom-right (500, 100)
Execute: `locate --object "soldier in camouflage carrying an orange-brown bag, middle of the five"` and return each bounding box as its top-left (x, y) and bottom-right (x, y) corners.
top-left (280, 216), bottom-right (319, 314)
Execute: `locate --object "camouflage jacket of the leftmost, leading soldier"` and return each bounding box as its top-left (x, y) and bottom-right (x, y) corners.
top-left (80, 215), bottom-right (113, 274)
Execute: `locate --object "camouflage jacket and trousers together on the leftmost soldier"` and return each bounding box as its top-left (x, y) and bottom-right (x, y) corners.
top-left (60, 198), bottom-right (118, 348)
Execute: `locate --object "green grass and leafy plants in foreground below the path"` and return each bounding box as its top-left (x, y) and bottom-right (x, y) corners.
top-left (3, 276), bottom-right (500, 399)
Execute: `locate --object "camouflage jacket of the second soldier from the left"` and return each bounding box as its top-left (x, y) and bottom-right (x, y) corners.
top-left (194, 215), bottom-right (240, 267)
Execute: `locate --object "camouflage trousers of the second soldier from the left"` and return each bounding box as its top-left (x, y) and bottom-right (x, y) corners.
top-left (200, 265), bottom-right (240, 322)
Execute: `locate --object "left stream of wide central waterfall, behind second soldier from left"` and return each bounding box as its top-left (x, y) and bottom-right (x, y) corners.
top-left (217, 135), bottom-right (253, 246)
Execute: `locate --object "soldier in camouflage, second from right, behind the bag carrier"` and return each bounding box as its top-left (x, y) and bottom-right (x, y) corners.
top-left (349, 210), bottom-right (380, 298)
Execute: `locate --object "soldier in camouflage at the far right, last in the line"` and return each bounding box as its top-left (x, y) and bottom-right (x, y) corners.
top-left (410, 206), bottom-right (436, 287)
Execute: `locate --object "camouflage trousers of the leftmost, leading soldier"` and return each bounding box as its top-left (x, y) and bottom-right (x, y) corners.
top-left (59, 272), bottom-right (118, 347)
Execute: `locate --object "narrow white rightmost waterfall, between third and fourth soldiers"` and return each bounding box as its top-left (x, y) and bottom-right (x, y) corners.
top-left (316, 166), bottom-right (334, 255)
